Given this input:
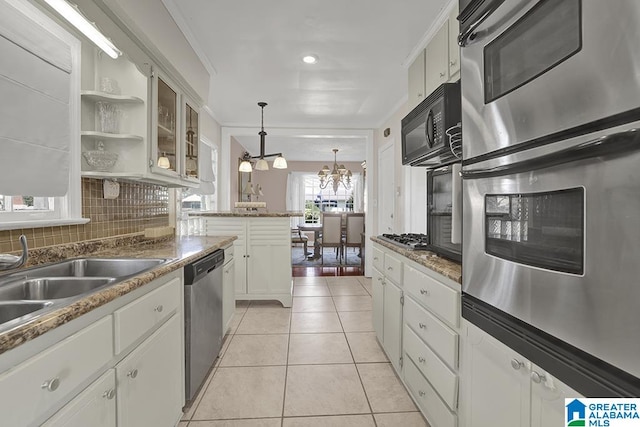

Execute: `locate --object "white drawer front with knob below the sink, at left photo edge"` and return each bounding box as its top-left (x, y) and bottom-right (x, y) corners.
top-left (0, 316), bottom-right (113, 427)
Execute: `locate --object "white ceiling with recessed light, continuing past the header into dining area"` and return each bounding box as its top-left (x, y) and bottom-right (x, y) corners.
top-left (163, 0), bottom-right (449, 161)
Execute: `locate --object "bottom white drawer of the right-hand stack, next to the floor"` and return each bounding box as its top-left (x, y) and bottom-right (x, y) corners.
top-left (404, 359), bottom-right (458, 427)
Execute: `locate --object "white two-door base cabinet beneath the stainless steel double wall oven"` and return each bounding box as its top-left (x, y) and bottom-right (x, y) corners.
top-left (460, 321), bottom-right (582, 427)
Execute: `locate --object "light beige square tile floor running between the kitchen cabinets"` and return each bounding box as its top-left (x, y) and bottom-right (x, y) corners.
top-left (179, 276), bottom-right (428, 427)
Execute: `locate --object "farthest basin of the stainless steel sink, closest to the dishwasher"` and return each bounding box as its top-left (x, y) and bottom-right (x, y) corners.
top-left (24, 258), bottom-right (167, 277)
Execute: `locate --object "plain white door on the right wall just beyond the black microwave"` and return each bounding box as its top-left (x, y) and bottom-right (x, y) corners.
top-left (378, 141), bottom-right (396, 234)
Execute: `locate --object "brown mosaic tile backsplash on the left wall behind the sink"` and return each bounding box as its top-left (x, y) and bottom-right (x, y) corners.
top-left (0, 178), bottom-right (169, 253)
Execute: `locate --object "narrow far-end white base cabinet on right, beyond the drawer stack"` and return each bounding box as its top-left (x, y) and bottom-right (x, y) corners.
top-left (372, 246), bottom-right (404, 372)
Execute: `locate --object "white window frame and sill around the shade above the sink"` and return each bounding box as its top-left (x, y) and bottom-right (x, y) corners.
top-left (0, 0), bottom-right (89, 230)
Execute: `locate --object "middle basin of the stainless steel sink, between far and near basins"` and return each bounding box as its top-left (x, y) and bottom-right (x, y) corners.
top-left (0, 277), bottom-right (116, 301)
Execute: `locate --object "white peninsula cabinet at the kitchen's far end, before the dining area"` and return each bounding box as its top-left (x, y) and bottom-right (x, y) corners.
top-left (205, 216), bottom-right (293, 307)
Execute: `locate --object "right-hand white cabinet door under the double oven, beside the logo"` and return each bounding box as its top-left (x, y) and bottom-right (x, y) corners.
top-left (531, 365), bottom-right (583, 427)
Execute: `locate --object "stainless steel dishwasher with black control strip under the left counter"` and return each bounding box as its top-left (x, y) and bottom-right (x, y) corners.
top-left (184, 249), bottom-right (224, 401)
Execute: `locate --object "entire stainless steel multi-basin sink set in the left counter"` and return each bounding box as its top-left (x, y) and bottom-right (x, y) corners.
top-left (0, 258), bottom-right (168, 332)
